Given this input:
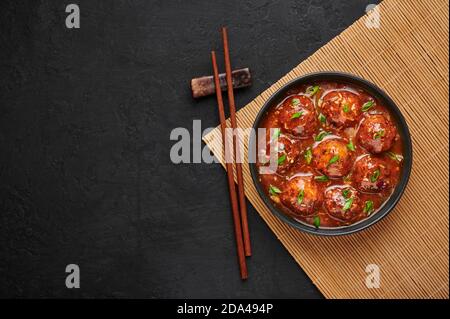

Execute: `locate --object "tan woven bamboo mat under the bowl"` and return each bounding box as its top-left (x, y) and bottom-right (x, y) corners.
top-left (204, 0), bottom-right (449, 298)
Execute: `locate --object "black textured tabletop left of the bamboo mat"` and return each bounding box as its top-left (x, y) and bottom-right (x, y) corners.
top-left (0, 0), bottom-right (374, 298)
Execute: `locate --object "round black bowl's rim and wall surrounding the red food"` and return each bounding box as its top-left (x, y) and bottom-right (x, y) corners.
top-left (249, 72), bottom-right (412, 236)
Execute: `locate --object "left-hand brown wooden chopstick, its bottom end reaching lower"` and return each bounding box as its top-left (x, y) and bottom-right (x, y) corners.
top-left (211, 51), bottom-right (248, 279)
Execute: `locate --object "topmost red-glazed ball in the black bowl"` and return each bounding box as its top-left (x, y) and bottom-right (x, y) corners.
top-left (321, 91), bottom-right (361, 127)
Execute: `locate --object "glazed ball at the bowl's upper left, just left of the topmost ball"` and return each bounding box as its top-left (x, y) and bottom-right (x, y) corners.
top-left (279, 95), bottom-right (318, 138)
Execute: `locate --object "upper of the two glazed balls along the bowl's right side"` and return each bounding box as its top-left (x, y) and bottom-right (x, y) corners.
top-left (357, 114), bottom-right (397, 154)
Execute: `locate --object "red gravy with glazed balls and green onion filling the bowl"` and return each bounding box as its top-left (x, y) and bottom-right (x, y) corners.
top-left (256, 82), bottom-right (403, 227)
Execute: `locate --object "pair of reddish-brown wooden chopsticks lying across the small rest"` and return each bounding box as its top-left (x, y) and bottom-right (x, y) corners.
top-left (211, 27), bottom-right (252, 279)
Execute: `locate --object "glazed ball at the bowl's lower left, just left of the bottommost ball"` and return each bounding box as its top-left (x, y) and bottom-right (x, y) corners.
top-left (280, 175), bottom-right (322, 217)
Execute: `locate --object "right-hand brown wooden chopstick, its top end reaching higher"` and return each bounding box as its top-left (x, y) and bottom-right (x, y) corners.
top-left (222, 27), bottom-right (252, 256)
